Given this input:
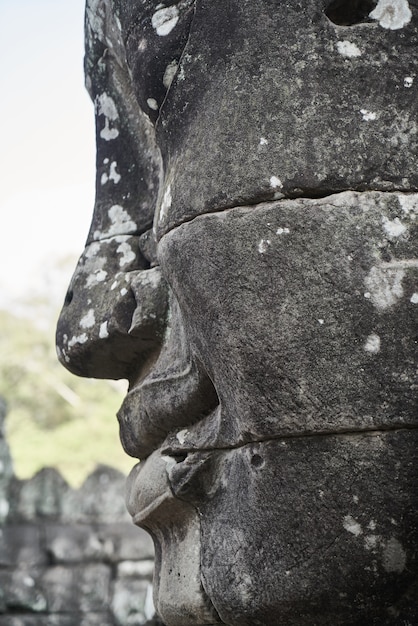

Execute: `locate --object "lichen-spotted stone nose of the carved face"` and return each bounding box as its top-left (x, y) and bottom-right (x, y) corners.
top-left (56, 235), bottom-right (167, 380)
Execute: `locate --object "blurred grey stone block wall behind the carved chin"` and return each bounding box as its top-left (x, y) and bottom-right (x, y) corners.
top-left (0, 399), bottom-right (160, 626)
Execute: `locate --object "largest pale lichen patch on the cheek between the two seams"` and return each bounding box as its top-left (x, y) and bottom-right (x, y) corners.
top-left (364, 264), bottom-right (405, 311)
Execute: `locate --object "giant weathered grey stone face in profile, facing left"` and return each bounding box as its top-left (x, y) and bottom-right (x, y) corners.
top-left (57, 0), bottom-right (418, 626)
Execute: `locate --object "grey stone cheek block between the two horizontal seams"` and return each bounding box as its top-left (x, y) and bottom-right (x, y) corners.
top-left (156, 192), bottom-right (418, 450)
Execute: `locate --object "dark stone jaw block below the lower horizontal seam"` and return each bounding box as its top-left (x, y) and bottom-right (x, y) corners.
top-left (198, 431), bottom-right (418, 626)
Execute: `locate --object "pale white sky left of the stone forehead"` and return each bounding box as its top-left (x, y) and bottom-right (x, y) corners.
top-left (0, 0), bottom-right (95, 308)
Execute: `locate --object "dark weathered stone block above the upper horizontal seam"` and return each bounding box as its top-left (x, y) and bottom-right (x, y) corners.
top-left (152, 0), bottom-right (418, 233)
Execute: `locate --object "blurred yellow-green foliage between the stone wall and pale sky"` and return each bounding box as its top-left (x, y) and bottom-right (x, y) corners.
top-left (0, 307), bottom-right (135, 486)
